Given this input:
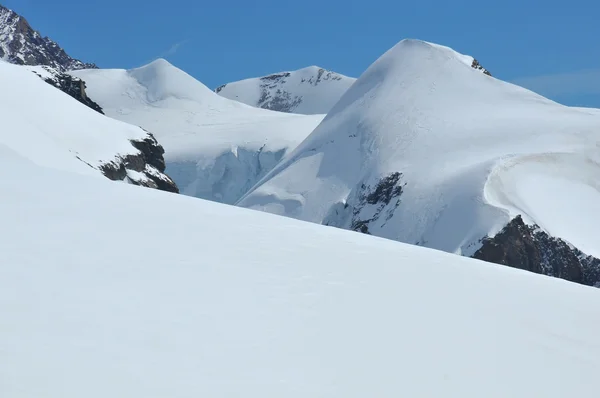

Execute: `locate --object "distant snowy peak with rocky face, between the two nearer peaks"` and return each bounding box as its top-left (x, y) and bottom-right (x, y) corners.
top-left (215, 66), bottom-right (356, 115)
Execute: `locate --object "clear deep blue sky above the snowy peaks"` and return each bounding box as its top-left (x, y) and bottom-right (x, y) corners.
top-left (0, 0), bottom-right (600, 107)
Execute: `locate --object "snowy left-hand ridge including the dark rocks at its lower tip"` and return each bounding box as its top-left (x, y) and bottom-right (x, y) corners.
top-left (0, 61), bottom-right (177, 192)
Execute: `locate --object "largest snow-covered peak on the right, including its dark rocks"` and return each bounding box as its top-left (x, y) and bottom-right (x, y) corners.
top-left (238, 40), bottom-right (600, 285)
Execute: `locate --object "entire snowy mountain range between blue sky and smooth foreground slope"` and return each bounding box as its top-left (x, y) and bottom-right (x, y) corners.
top-left (0, 6), bottom-right (600, 286)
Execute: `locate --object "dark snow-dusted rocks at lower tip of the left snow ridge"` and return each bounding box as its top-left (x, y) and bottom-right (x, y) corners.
top-left (100, 133), bottom-right (179, 193)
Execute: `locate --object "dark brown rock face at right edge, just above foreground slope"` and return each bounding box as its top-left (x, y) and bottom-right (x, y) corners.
top-left (473, 216), bottom-right (600, 286)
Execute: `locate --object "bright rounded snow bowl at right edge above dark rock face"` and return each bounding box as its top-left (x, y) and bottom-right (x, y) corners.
top-left (484, 154), bottom-right (600, 258)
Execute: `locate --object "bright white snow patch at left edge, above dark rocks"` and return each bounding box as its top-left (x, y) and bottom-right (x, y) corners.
top-left (0, 61), bottom-right (152, 175)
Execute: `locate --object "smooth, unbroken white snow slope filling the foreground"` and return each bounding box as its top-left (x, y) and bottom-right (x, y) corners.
top-left (0, 145), bottom-right (600, 398)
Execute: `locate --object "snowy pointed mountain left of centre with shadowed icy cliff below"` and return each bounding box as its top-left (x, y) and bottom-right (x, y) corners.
top-left (71, 59), bottom-right (323, 204)
